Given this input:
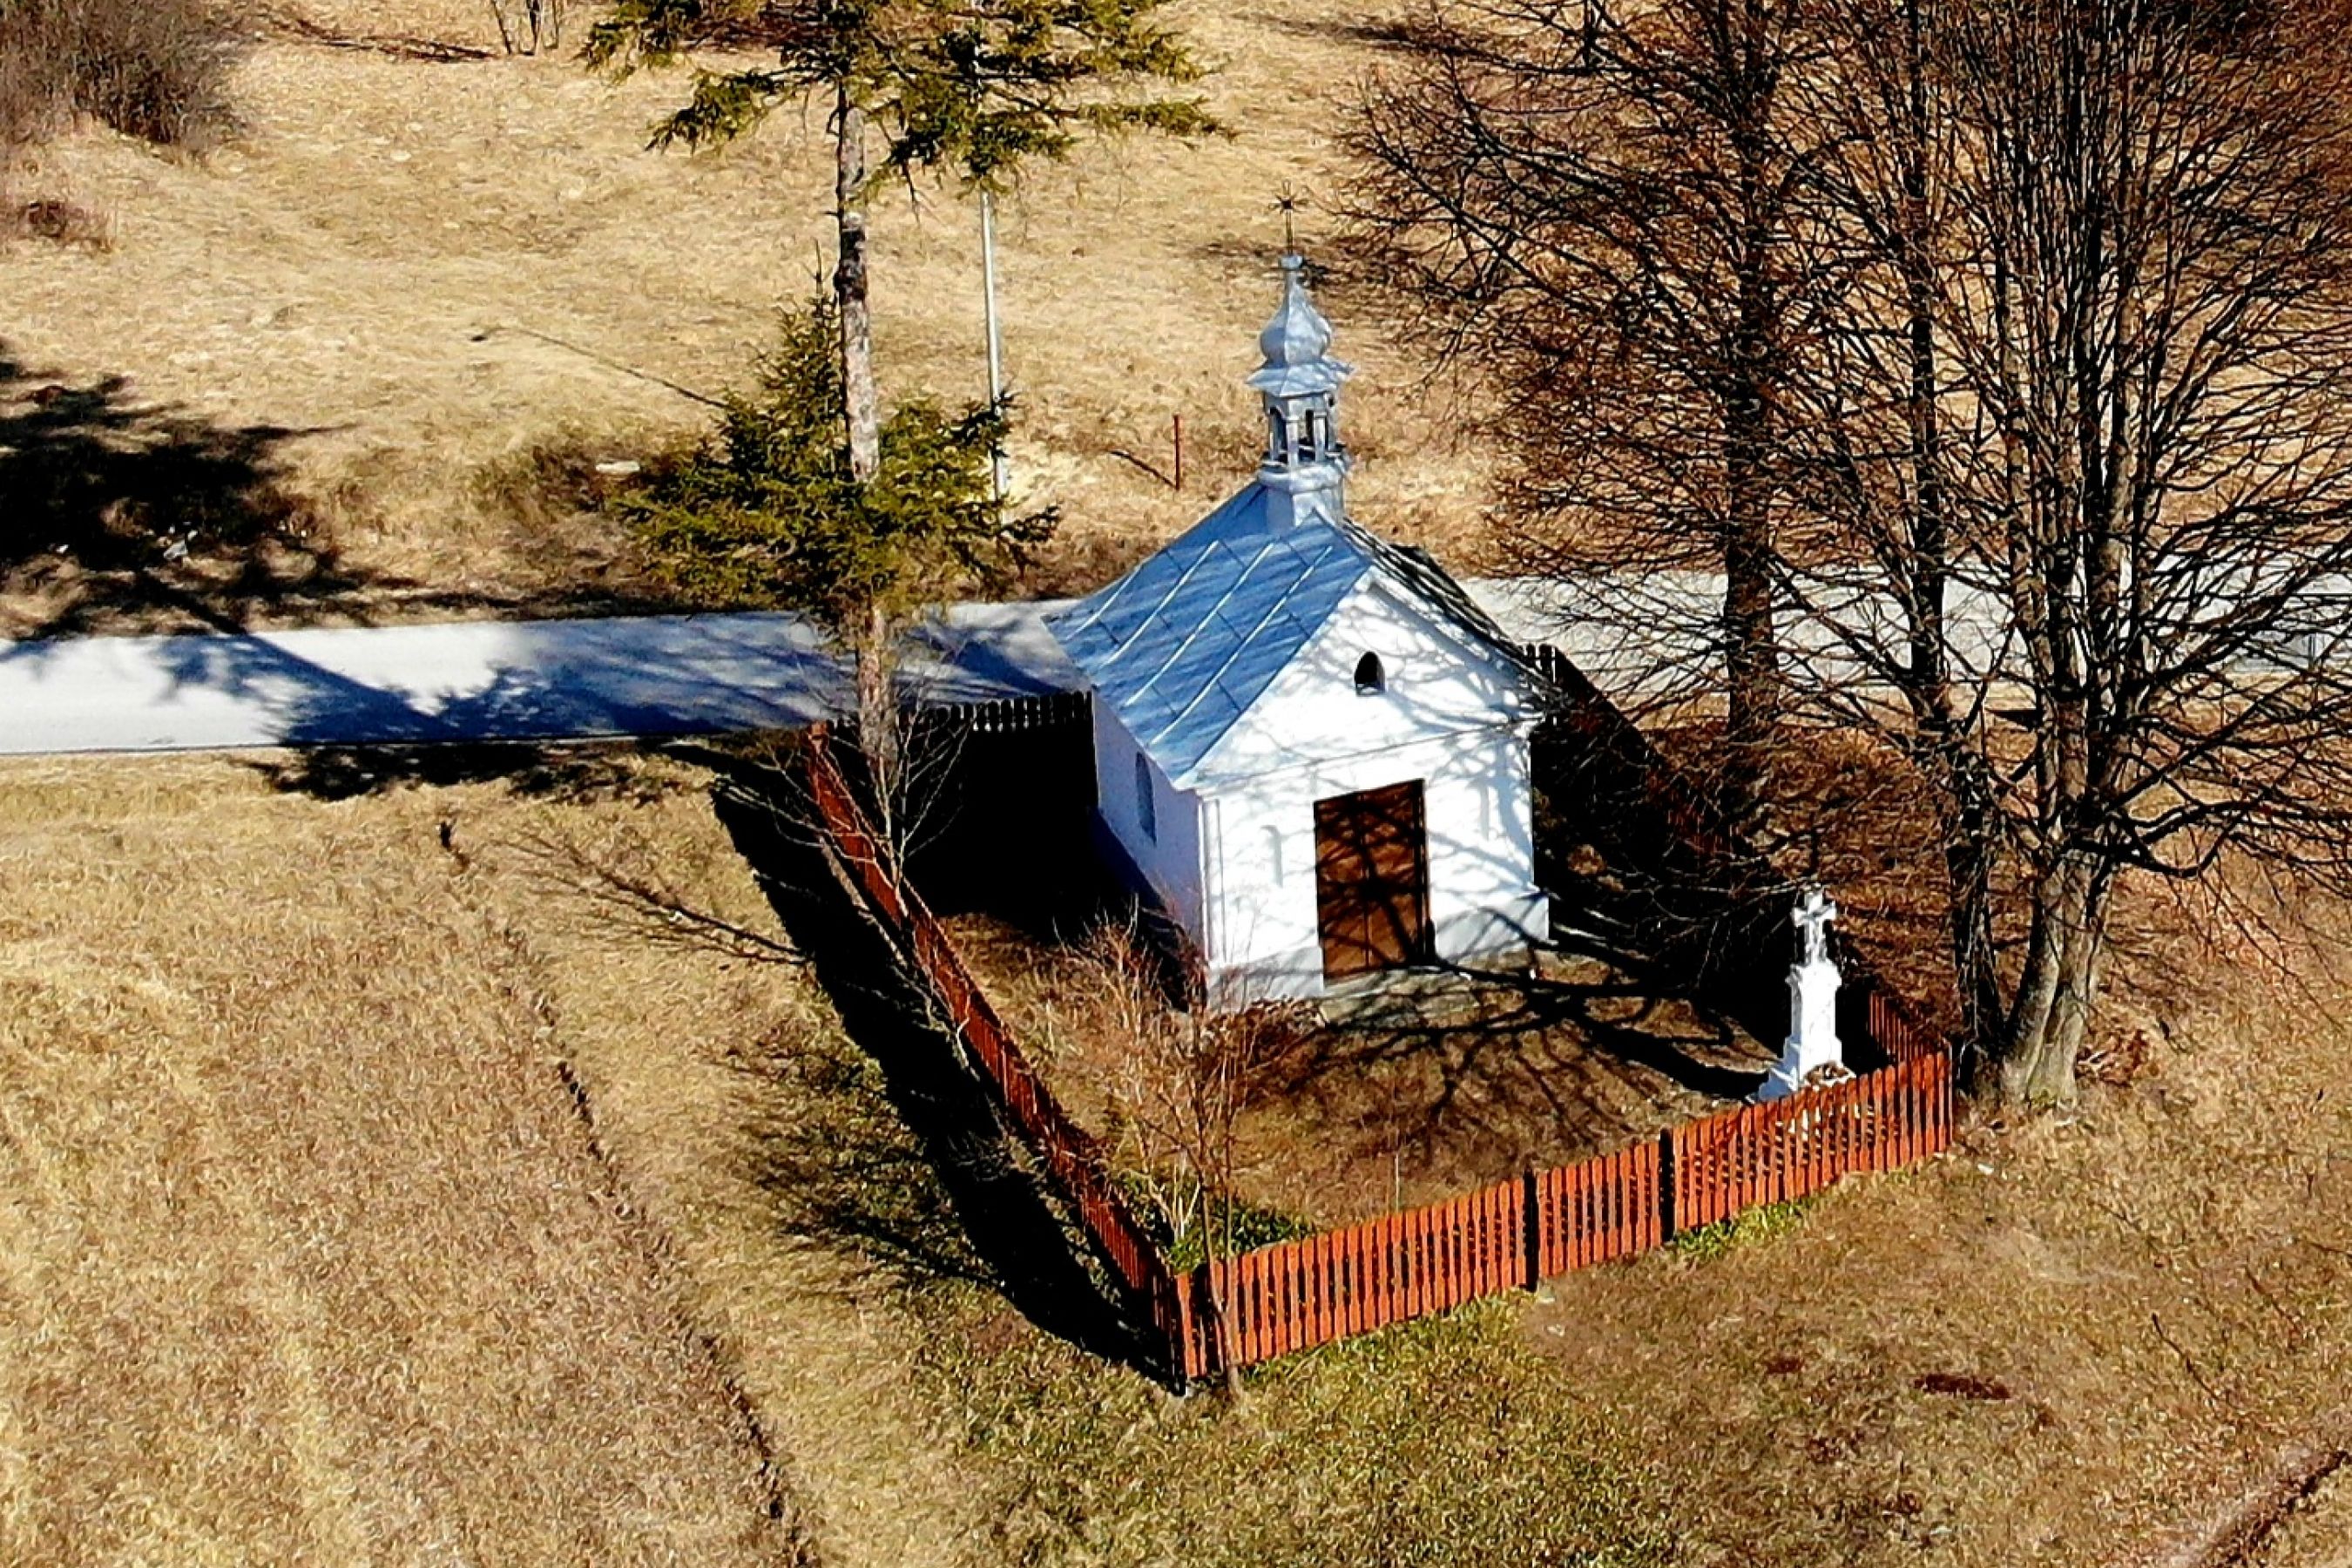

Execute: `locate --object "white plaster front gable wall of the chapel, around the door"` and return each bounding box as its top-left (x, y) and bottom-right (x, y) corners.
top-left (1202, 588), bottom-right (1550, 1002)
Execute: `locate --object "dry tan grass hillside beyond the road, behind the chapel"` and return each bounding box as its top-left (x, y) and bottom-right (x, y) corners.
top-left (0, 0), bottom-right (1484, 630)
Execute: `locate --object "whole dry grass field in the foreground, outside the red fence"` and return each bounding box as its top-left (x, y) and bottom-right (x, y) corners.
top-left (0, 753), bottom-right (2352, 1568)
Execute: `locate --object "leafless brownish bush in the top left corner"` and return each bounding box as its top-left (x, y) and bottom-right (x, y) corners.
top-left (0, 0), bottom-right (238, 148)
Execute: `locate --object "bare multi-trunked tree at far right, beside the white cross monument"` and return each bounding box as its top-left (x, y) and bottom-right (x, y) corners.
top-left (1783, 0), bottom-right (2352, 1103)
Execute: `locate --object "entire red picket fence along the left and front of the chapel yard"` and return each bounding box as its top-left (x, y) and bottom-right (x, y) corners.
top-left (807, 724), bottom-right (1952, 1380)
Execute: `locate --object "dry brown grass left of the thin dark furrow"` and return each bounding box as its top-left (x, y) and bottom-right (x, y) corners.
top-left (0, 761), bottom-right (788, 1564)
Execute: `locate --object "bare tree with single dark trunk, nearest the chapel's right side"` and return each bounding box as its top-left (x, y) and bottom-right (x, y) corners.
top-left (1350, 0), bottom-right (1823, 814)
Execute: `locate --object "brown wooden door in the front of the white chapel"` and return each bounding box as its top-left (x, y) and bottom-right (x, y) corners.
top-left (1315, 778), bottom-right (1430, 980)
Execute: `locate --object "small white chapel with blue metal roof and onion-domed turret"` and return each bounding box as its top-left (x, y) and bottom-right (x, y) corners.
top-left (1049, 256), bottom-right (1550, 1006)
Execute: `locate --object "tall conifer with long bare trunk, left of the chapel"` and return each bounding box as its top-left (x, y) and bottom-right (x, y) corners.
top-left (585, 0), bottom-right (1219, 808)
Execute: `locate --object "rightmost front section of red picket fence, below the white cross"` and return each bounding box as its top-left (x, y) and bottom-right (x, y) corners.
top-left (1667, 1053), bottom-right (1952, 1229)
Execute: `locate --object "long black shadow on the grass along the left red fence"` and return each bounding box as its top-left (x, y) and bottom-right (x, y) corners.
top-left (715, 774), bottom-right (1165, 1373)
